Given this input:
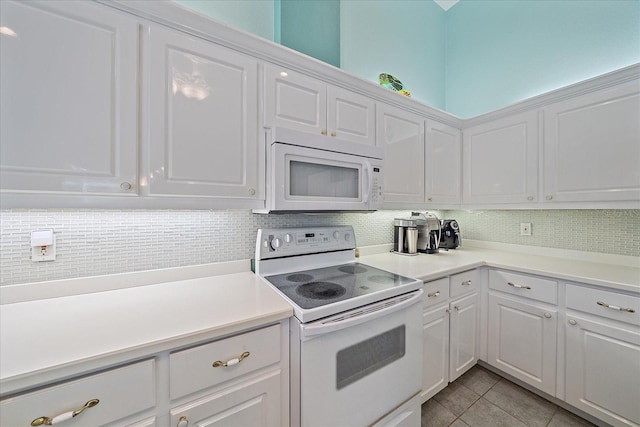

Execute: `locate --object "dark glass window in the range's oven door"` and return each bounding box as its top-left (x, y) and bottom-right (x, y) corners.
top-left (336, 325), bottom-right (405, 390)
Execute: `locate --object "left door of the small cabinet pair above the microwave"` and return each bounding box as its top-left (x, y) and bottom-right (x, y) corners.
top-left (264, 64), bottom-right (327, 135)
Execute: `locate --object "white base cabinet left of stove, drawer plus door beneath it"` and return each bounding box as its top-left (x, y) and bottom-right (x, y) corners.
top-left (170, 325), bottom-right (288, 427)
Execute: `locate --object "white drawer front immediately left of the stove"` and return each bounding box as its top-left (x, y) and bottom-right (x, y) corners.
top-left (169, 325), bottom-right (281, 399)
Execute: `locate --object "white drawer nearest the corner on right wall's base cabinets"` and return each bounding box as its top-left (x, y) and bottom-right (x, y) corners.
top-left (489, 270), bottom-right (558, 304)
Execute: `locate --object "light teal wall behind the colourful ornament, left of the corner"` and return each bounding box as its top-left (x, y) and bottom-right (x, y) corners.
top-left (340, 0), bottom-right (446, 109)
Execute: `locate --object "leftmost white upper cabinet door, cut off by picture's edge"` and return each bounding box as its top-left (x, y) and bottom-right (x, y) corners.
top-left (0, 1), bottom-right (139, 196)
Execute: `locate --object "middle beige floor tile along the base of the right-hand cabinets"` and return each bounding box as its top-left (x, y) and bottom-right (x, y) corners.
top-left (484, 379), bottom-right (557, 427)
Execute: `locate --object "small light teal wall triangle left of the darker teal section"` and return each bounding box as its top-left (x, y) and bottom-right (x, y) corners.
top-left (173, 0), bottom-right (275, 41)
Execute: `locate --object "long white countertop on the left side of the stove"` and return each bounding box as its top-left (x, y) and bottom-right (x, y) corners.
top-left (0, 272), bottom-right (293, 395)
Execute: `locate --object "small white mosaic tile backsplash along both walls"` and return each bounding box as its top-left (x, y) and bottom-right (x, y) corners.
top-left (0, 209), bottom-right (640, 285)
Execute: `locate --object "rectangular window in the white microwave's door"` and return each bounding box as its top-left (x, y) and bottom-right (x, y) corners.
top-left (288, 158), bottom-right (361, 200)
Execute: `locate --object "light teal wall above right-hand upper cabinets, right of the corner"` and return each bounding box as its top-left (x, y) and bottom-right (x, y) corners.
top-left (444, 0), bottom-right (640, 118)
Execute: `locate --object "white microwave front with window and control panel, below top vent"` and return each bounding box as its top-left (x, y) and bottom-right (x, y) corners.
top-left (267, 143), bottom-right (382, 211)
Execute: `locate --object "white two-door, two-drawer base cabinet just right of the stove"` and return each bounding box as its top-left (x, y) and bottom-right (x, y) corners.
top-left (421, 270), bottom-right (480, 402)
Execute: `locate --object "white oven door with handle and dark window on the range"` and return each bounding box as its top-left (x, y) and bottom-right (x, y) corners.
top-left (292, 290), bottom-right (422, 427)
